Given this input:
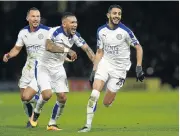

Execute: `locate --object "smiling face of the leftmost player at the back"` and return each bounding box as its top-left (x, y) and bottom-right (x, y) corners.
top-left (27, 10), bottom-right (41, 27)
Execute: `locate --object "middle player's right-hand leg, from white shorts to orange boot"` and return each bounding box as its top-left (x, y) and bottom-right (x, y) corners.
top-left (47, 67), bottom-right (69, 130)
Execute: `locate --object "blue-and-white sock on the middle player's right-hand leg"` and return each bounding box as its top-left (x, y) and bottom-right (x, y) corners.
top-left (48, 101), bottom-right (65, 125)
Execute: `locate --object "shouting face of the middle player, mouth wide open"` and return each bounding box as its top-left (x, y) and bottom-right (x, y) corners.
top-left (65, 16), bottom-right (77, 35)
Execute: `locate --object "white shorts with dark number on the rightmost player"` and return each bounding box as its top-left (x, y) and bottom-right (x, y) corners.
top-left (94, 58), bottom-right (131, 92)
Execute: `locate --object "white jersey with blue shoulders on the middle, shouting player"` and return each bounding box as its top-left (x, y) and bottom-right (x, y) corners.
top-left (41, 26), bottom-right (86, 67)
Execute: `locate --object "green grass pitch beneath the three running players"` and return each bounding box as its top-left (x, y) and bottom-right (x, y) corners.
top-left (0, 91), bottom-right (179, 136)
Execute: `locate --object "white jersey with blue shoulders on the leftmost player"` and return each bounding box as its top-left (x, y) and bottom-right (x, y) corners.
top-left (16, 24), bottom-right (49, 65)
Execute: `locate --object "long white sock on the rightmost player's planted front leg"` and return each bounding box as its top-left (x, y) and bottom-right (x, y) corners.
top-left (86, 89), bottom-right (100, 127)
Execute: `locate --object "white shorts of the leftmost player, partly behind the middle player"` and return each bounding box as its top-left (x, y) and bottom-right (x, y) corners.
top-left (18, 62), bottom-right (38, 92)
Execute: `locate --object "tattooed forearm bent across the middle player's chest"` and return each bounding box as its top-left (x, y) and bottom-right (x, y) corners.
top-left (46, 39), bottom-right (64, 53)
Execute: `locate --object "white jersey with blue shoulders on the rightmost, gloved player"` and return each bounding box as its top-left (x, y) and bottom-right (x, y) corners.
top-left (97, 23), bottom-right (139, 66)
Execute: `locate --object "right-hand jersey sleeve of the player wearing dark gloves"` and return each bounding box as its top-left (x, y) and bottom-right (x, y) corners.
top-left (126, 30), bottom-right (139, 46)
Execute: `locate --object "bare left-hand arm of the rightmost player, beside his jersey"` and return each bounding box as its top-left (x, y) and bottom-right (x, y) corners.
top-left (93, 49), bottom-right (104, 71)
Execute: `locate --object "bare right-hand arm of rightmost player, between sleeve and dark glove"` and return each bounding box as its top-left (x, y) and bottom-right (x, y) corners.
top-left (135, 44), bottom-right (143, 66)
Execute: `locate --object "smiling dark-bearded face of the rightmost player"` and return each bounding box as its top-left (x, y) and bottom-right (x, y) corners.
top-left (108, 8), bottom-right (122, 25)
